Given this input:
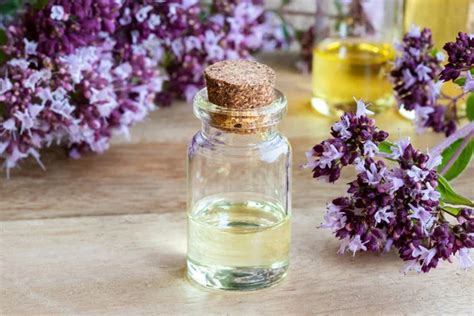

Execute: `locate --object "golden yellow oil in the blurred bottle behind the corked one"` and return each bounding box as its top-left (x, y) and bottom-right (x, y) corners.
top-left (312, 40), bottom-right (395, 115)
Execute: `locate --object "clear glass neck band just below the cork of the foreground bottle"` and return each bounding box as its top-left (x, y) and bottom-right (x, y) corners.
top-left (201, 122), bottom-right (278, 146)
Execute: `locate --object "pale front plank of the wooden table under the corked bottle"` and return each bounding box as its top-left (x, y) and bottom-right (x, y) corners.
top-left (0, 209), bottom-right (474, 315)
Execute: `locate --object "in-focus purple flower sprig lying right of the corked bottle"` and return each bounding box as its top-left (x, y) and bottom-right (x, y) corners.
top-left (312, 100), bottom-right (474, 272)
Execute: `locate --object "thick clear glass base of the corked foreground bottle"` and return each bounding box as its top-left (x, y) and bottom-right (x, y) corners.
top-left (187, 259), bottom-right (288, 291)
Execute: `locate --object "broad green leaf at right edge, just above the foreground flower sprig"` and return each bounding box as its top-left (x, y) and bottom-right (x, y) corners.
top-left (438, 138), bottom-right (474, 181)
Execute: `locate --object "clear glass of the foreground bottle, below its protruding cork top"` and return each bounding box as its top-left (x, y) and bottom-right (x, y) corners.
top-left (187, 89), bottom-right (291, 290)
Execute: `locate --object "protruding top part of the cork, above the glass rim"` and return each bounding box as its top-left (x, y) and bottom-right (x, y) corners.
top-left (204, 60), bottom-right (275, 109)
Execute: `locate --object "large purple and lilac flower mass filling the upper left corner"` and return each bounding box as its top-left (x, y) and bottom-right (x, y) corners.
top-left (0, 1), bottom-right (166, 175)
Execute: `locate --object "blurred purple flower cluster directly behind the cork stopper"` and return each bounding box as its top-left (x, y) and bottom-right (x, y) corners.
top-left (157, 0), bottom-right (286, 101)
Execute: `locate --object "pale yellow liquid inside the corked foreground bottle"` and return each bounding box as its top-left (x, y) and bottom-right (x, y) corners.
top-left (188, 196), bottom-right (290, 289)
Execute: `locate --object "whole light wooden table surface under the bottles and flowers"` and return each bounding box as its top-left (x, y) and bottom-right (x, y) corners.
top-left (0, 56), bottom-right (474, 315)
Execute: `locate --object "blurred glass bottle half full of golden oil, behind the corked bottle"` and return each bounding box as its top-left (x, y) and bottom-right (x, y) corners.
top-left (311, 0), bottom-right (403, 115)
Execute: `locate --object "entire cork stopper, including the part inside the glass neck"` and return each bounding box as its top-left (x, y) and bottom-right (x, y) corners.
top-left (204, 60), bottom-right (275, 134)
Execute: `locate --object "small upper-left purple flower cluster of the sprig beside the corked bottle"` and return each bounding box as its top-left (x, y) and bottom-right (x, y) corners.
top-left (305, 100), bottom-right (388, 182)
